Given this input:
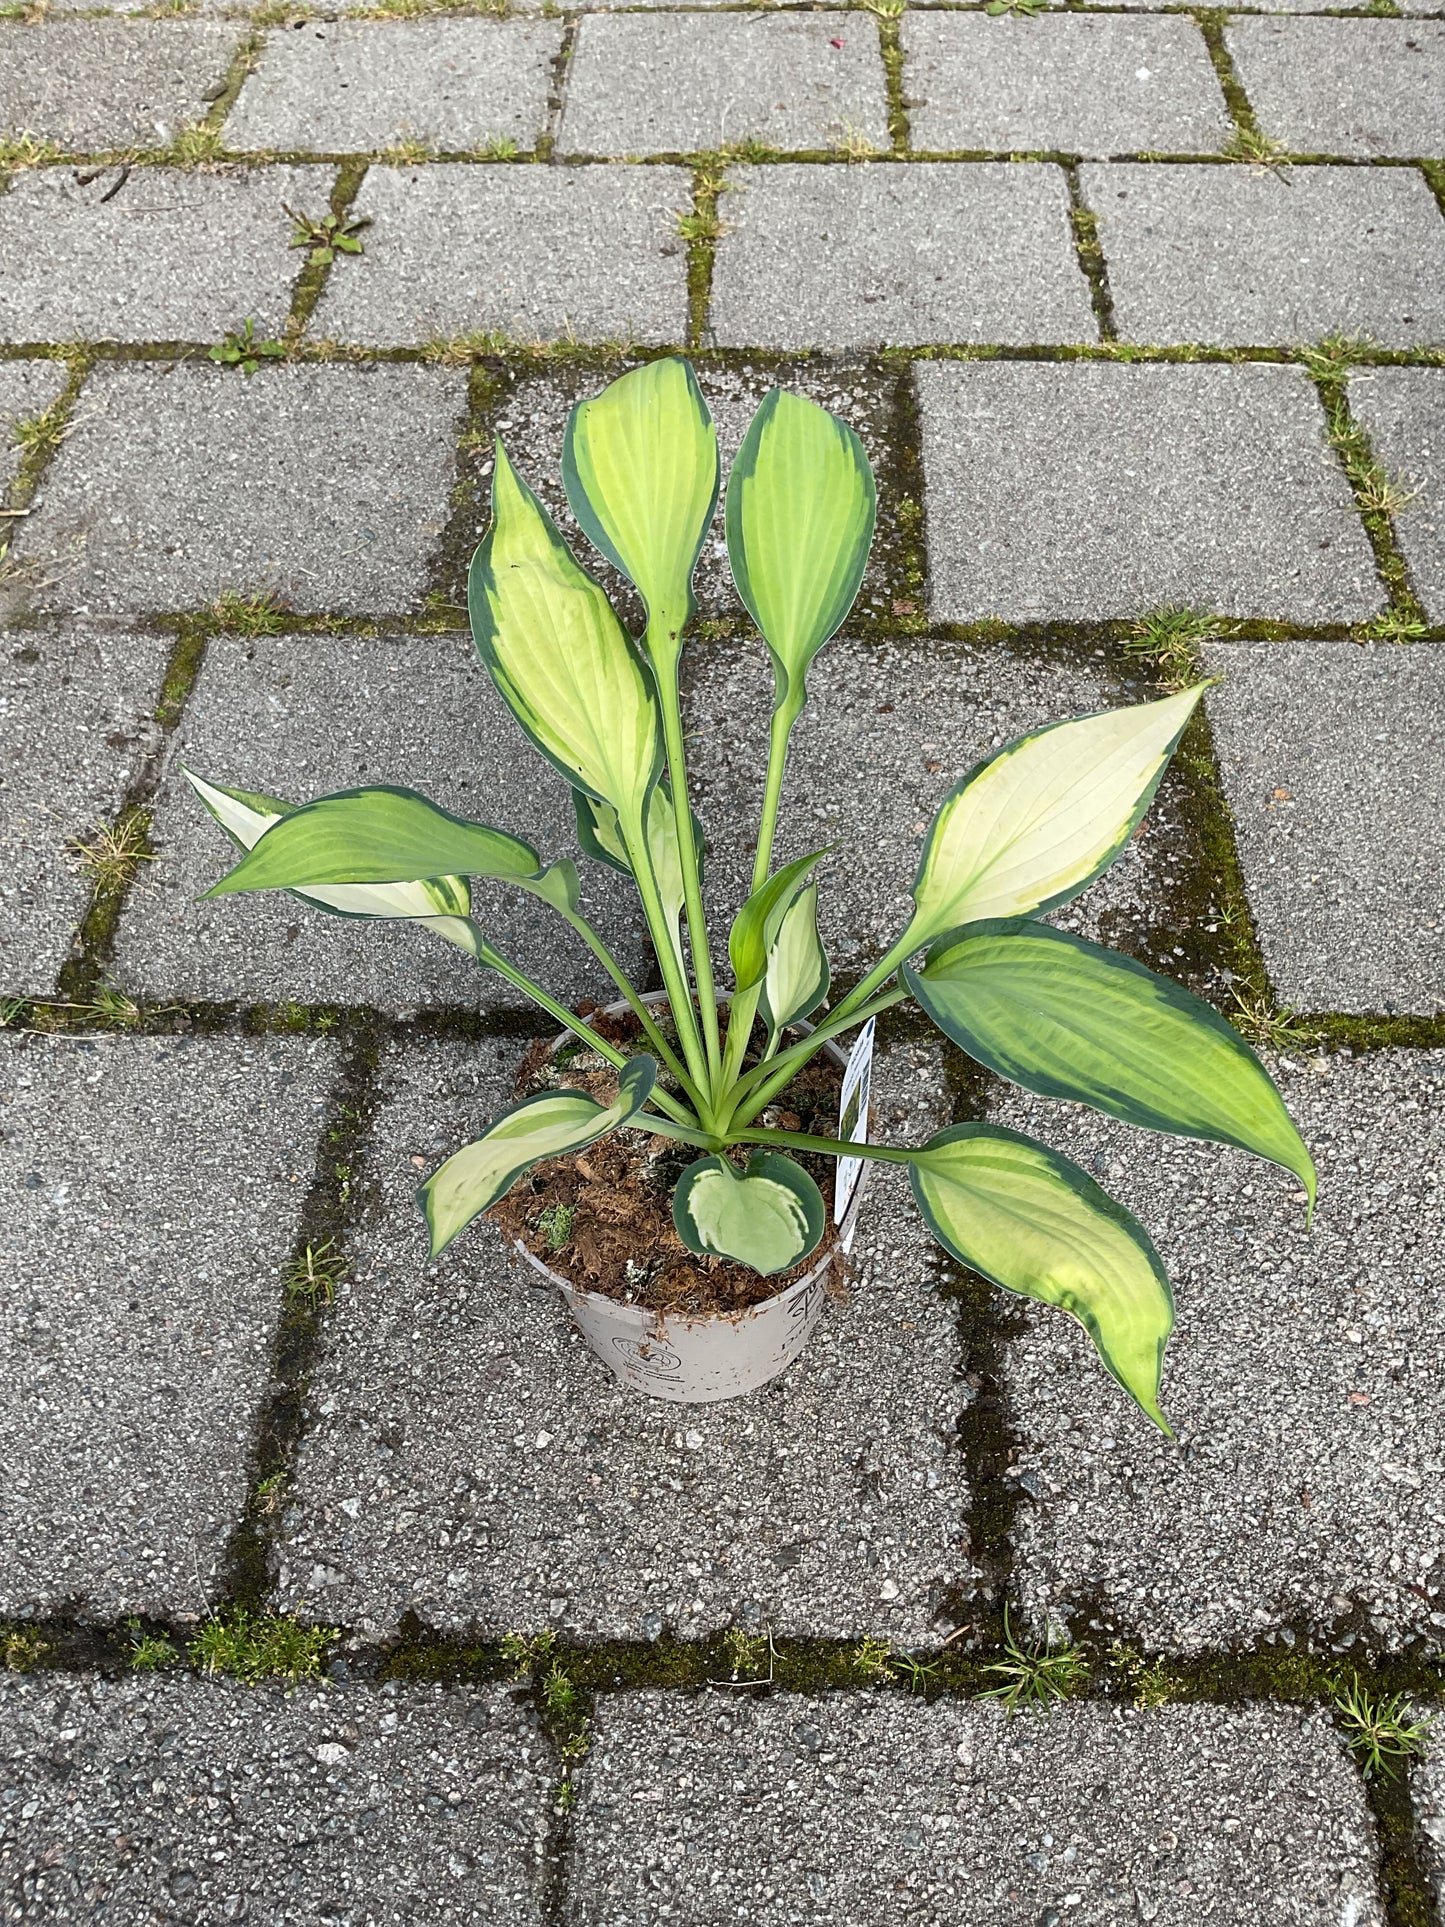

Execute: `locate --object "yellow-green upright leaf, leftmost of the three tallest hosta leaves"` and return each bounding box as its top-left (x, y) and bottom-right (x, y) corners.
top-left (466, 443), bottom-right (663, 827)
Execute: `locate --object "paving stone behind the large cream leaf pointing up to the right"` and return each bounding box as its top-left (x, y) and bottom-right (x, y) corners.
top-left (688, 640), bottom-right (1187, 977)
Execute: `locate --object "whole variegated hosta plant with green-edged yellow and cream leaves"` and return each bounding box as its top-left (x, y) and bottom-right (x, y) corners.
top-left (191, 360), bottom-right (1314, 1424)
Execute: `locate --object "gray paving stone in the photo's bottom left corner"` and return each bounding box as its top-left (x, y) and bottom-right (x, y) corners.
top-left (0, 1673), bottom-right (555, 1927)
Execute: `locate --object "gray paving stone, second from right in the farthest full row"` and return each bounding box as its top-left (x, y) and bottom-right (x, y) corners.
top-left (902, 12), bottom-right (1231, 154)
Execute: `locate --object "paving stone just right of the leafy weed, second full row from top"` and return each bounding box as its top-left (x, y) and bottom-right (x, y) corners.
top-left (312, 164), bottom-right (692, 347)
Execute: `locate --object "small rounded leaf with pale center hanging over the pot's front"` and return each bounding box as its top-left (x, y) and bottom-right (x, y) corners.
top-left (672, 1150), bottom-right (827, 1278)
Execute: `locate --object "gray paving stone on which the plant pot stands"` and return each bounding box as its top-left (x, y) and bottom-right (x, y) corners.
top-left (279, 1041), bottom-right (971, 1646)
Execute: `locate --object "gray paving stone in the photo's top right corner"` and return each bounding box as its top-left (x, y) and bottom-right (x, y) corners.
top-left (1225, 19), bottom-right (1445, 156)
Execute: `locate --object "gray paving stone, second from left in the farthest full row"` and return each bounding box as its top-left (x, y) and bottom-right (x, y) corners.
top-left (225, 17), bottom-right (563, 154)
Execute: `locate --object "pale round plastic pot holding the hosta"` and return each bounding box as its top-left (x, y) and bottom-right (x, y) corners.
top-left (516, 996), bottom-right (869, 1405)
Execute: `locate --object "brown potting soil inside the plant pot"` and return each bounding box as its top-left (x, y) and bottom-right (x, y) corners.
top-left (487, 1012), bottom-right (842, 1316)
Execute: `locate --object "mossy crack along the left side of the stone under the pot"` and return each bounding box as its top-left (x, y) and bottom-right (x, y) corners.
top-left (222, 1019), bottom-right (381, 1595)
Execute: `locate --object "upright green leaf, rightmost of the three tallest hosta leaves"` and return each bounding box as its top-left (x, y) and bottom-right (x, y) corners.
top-left (726, 387), bottom-right (877, 717)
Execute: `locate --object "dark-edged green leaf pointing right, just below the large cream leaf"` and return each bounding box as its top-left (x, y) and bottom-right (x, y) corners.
top-left (904, 917), bottom-right (1314, 1204)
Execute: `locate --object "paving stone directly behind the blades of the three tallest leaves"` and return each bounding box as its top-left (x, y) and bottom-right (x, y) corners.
top-left (455, 356), bottom-right (917, 628)
